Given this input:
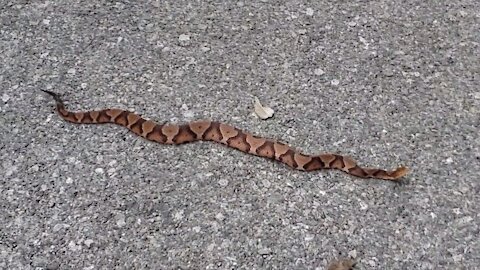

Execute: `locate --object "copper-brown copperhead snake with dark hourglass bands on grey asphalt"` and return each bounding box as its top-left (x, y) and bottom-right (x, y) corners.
top-left (42, 90), bottom-right (408, 180)
